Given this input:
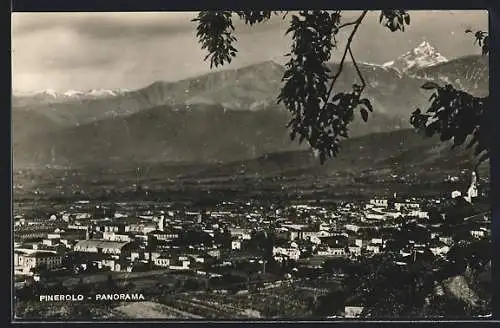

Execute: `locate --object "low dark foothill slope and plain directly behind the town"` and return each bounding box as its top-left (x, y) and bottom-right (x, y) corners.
top-left (15, 130), bottom-right (489, 199)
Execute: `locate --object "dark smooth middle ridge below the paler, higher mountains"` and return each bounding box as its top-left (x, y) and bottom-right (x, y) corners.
top-left (14, 105), bottom-right (405, 168)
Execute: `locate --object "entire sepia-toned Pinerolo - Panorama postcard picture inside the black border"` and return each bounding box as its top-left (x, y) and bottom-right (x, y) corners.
top-left (12, 10), bottom-right (493, 322)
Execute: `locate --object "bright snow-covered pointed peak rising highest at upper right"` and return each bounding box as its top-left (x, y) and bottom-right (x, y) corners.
top-left (382, 41), bottom-right (448, 73)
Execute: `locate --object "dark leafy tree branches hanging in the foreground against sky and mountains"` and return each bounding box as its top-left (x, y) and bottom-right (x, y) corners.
top-left (193, 10), bottom-right (489, 164)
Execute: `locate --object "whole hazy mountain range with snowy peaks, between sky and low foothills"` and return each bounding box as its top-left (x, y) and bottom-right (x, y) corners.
top-left (12, 43), bottom-right (488, 174)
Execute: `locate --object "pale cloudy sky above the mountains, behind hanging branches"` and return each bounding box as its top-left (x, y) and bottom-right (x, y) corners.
top-left (11, 11), bottom-right (488, 92)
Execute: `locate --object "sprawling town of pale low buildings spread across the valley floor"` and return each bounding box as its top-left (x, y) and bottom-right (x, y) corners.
top-left (14, 173), bottom-right (491, 319)
